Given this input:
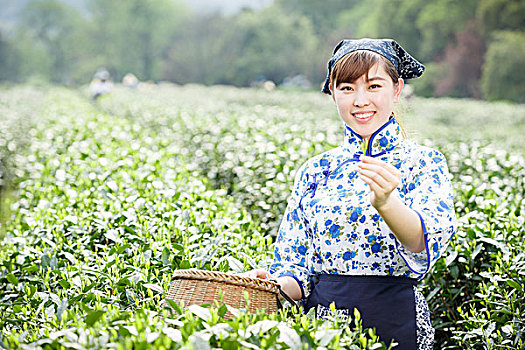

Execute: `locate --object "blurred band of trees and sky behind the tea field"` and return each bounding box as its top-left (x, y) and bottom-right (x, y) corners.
top-left (0, 0), bottom-right (525, 103)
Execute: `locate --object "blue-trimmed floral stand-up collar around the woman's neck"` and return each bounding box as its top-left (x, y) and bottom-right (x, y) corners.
top-left (343, 117), bottom-right (403, 158)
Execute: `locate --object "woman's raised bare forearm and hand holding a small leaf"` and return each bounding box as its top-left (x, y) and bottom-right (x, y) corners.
top-left (359, 156), bottom-right (425, 253)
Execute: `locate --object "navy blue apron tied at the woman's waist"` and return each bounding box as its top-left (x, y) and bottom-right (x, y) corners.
top-left (306, 274), bottom-right (417, 350)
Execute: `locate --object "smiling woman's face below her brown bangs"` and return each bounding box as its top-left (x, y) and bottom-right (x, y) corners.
top-left (331, 64), bottom-right (403, 138)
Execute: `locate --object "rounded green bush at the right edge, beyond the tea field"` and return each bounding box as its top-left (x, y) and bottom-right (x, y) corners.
top-left (481, 32), bottom-right (525, 103)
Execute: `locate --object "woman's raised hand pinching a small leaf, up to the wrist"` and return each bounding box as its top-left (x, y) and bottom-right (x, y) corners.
top-left (358, 156), bottom-right (401, 211)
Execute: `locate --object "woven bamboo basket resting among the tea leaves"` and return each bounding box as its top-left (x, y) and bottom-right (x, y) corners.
top-left (166, 270), bottom-right (279, 318)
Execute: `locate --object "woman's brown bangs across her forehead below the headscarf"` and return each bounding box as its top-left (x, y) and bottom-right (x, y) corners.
top-left (330, 50), bottom-right (388, 88)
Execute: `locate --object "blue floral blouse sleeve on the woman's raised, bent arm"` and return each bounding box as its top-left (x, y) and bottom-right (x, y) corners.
top-left (396, 147), bottom-right (457, 276)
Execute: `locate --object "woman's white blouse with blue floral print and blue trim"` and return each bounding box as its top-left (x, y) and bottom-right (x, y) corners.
top-left (270, 118), bottom-right (456, 297)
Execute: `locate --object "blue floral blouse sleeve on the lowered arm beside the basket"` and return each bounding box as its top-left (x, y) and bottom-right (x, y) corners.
top-left (270, 164), bottom-right (312, 298)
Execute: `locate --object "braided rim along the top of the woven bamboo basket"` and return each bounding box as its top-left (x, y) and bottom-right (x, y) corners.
top-left (172, 269), bottom-right (279, 294)
